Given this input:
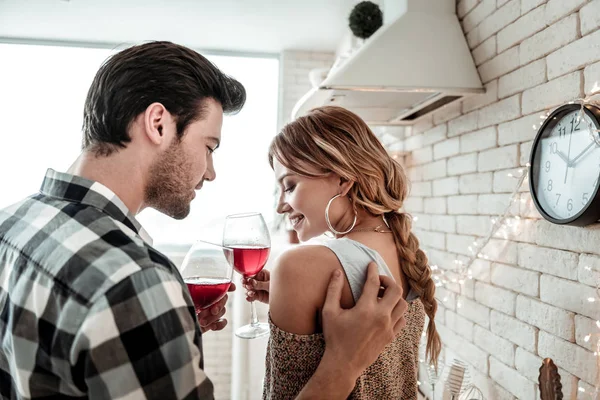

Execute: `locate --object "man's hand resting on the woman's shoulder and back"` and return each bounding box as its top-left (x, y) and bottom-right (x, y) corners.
top-left (323, 263), bottom-right (408, 379)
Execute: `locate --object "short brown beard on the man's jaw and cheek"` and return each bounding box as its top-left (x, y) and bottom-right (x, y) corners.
top-left (145, 139), bottom-right (192, 219)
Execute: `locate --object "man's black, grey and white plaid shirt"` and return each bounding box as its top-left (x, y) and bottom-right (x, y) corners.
top-left (0, 170), bottom-right (213, 400)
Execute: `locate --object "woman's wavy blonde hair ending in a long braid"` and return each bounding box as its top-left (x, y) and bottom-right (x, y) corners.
top-left (269, 106), bottom-right (441, 366)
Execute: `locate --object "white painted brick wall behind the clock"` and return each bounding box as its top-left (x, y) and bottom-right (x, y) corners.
top-left (394, 0), bottom-right (600, 399)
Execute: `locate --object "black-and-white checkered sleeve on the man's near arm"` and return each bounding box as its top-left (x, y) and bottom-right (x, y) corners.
top-left (73, 266), bottom-right (213, 399)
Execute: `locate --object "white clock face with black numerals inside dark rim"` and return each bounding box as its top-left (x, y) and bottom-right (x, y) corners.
top-left (531, 106), bottom-right (600, 222)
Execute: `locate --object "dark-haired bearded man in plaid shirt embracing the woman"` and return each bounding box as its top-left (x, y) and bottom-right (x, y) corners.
top-left (0, 42), bottom-right (406, 399)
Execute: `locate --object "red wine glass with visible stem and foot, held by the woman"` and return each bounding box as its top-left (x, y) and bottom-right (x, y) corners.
top-left (223, 213), bottom-right (271, 339)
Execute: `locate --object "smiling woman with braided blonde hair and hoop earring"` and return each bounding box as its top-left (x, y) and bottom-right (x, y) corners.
top-left (249, 107), bottom-right (441, 400)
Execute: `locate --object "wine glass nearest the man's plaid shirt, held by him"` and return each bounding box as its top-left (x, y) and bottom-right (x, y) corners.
top-left (181, 241), bottom-right (233, 314)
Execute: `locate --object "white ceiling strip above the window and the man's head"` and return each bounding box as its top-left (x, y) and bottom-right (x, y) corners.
top-left (0, 0), bottom-right (381, 53)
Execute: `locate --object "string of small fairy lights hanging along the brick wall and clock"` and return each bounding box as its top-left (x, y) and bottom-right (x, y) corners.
top-left (398, 90), bottom-right (600, 400)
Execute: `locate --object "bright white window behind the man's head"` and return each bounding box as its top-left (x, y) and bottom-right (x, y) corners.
top-left (0, 44), bottom-right (279, 247)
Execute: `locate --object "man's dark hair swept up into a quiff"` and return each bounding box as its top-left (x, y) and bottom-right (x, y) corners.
top-left (83, 42), bottom-right (246, 155)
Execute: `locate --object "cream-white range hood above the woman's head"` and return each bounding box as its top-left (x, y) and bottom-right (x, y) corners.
top-left (292, 0), bottom-right (485, 125)
